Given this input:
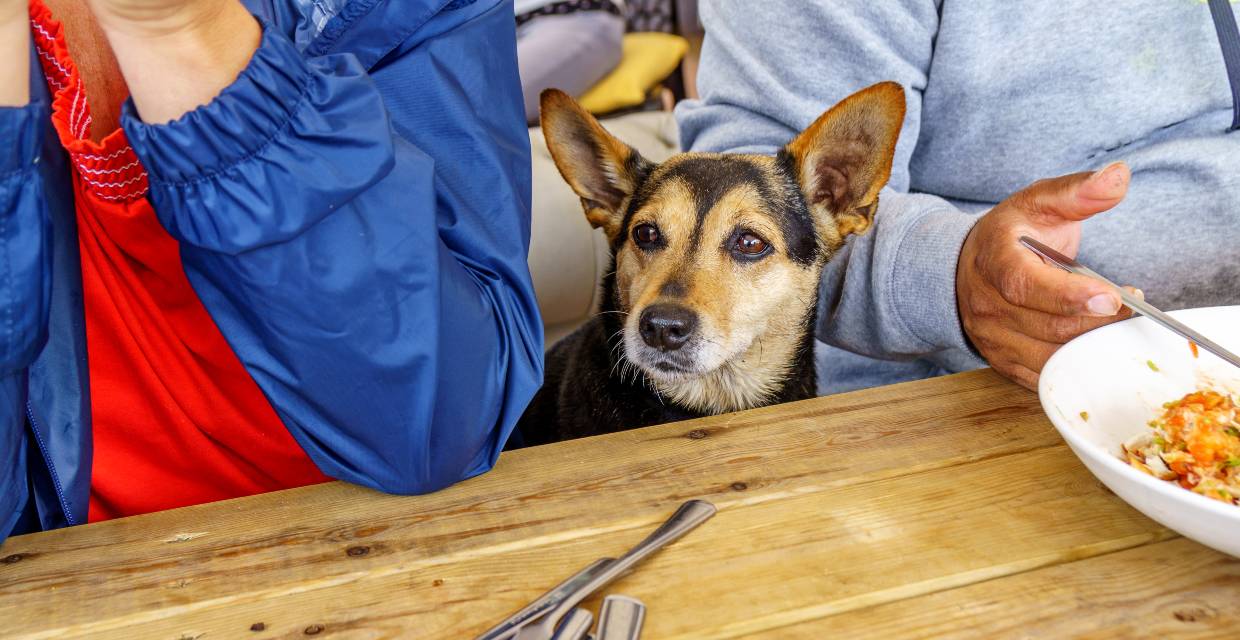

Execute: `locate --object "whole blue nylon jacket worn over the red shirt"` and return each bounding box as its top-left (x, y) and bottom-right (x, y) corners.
top-left (0, 0), bottom-right (542, 541)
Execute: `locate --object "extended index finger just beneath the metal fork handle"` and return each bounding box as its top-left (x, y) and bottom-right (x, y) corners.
top-left (980, 248), bottom-right (1121, 318)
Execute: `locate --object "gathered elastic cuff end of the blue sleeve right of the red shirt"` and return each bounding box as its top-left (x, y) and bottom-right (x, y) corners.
top-left (123, 18), bottom-right (394, 254)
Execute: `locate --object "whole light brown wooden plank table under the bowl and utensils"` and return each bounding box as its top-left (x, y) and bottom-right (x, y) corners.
top-left (0, 371), bottom-right (1240, 640)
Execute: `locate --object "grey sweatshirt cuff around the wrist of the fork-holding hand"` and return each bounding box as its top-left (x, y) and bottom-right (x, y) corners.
top-left (889, 208), bottom-right (977, 355)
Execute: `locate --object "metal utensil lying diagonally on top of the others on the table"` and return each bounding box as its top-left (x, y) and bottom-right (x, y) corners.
top-left (517, 500), bottom-right (717, 640)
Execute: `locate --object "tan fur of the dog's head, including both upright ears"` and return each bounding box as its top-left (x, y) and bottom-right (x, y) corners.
top-left (530, 83), bottom-right (904, 424)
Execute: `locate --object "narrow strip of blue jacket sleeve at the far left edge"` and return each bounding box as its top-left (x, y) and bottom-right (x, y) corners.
top-left (0, 103), bottom-right (51, 542)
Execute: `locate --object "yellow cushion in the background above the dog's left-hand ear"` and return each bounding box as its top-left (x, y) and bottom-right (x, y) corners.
top-left (580, 32), bottom-right (689, 113)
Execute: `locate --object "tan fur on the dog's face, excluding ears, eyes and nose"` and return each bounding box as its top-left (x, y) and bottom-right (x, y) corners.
top-left (616, 156), bottom-right (821, 413)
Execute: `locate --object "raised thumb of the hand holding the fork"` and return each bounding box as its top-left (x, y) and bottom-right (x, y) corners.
top-left (1013, 162), bottom-right (1132, 224)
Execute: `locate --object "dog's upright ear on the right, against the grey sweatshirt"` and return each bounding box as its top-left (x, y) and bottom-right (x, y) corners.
top-left (784, 82), bottom-right (904, 237)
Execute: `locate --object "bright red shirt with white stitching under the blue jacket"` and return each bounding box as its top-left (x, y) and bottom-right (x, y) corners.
top-left (30, 0), bottom-right (326, 521)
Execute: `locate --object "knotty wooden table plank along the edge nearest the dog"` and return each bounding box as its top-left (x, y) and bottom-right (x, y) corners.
top-left (0, 372), bottom-right (1059, 630)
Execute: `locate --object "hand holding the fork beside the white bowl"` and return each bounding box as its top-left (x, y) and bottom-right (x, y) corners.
top-left (956, 162), bottom-right (1131, 389)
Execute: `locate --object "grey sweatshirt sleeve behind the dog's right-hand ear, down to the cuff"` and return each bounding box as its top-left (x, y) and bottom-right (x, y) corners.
top-left (677, 0), bottom-right (980, 366)
